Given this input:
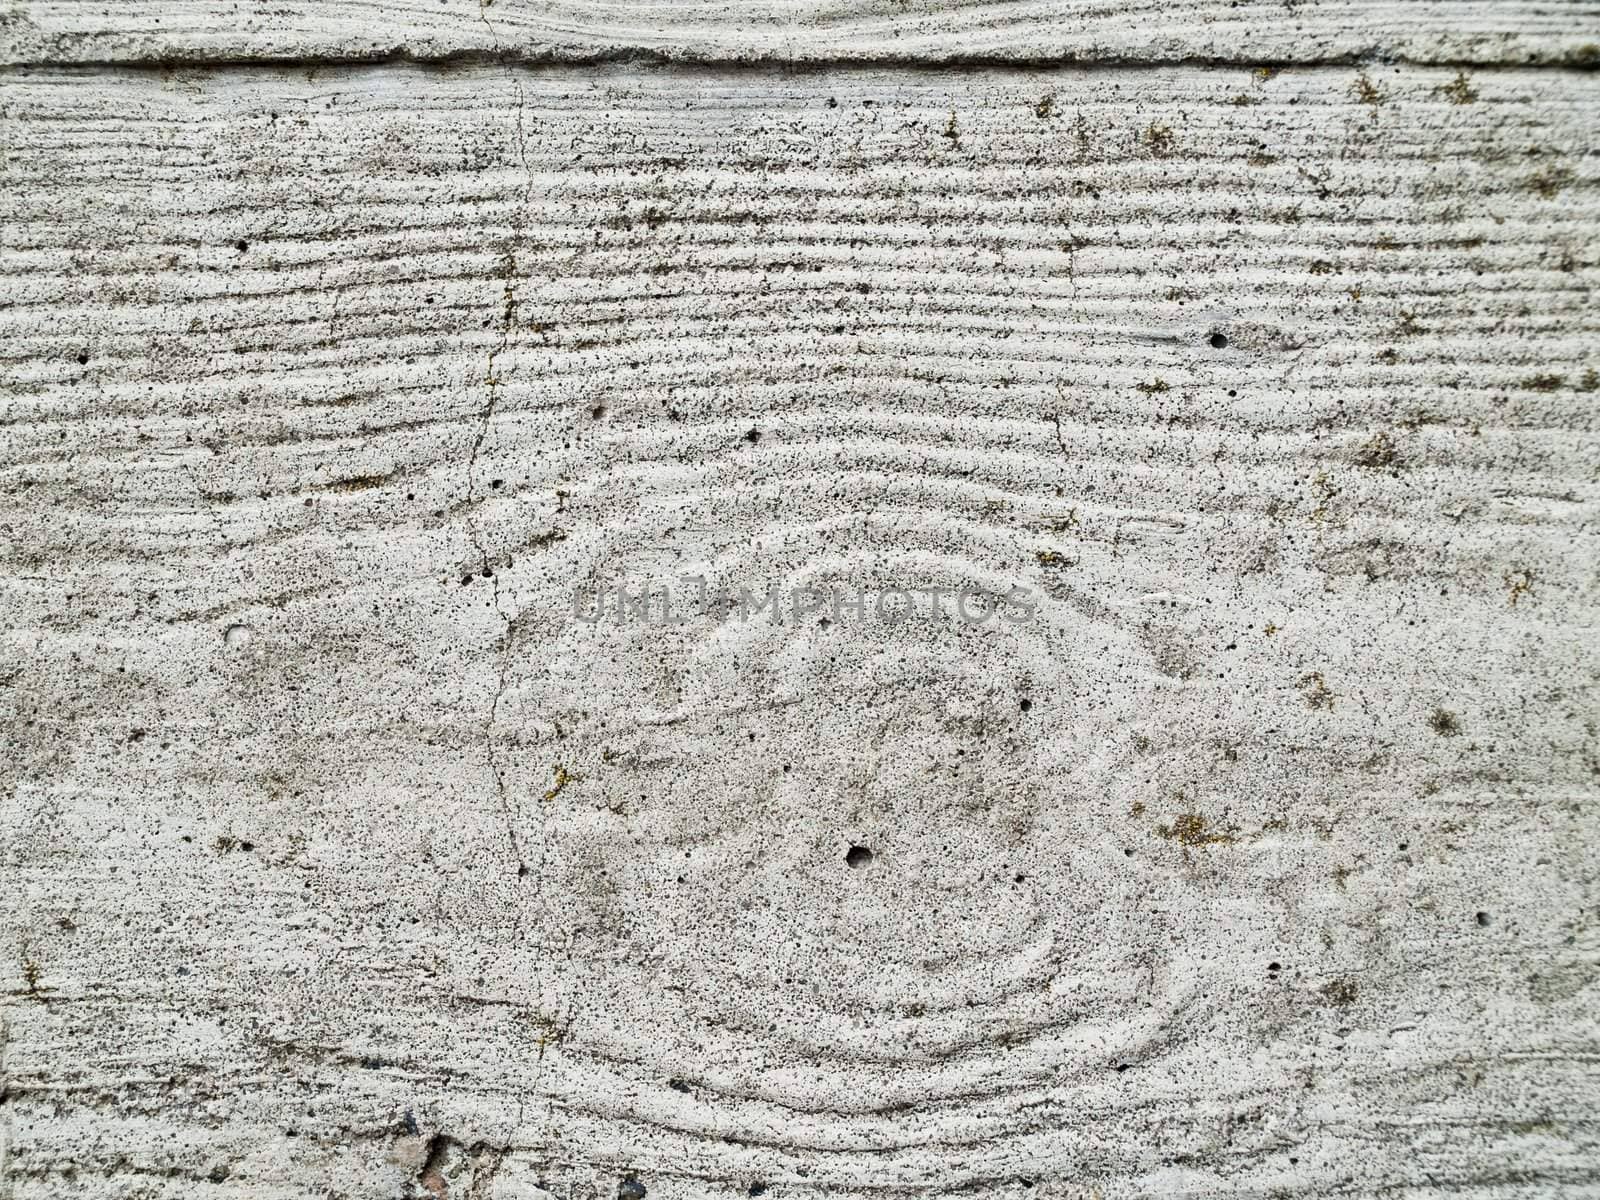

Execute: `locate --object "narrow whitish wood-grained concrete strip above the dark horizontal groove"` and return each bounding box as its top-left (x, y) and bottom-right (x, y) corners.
top-left (9, 0), bottom-right (1600, 67)
